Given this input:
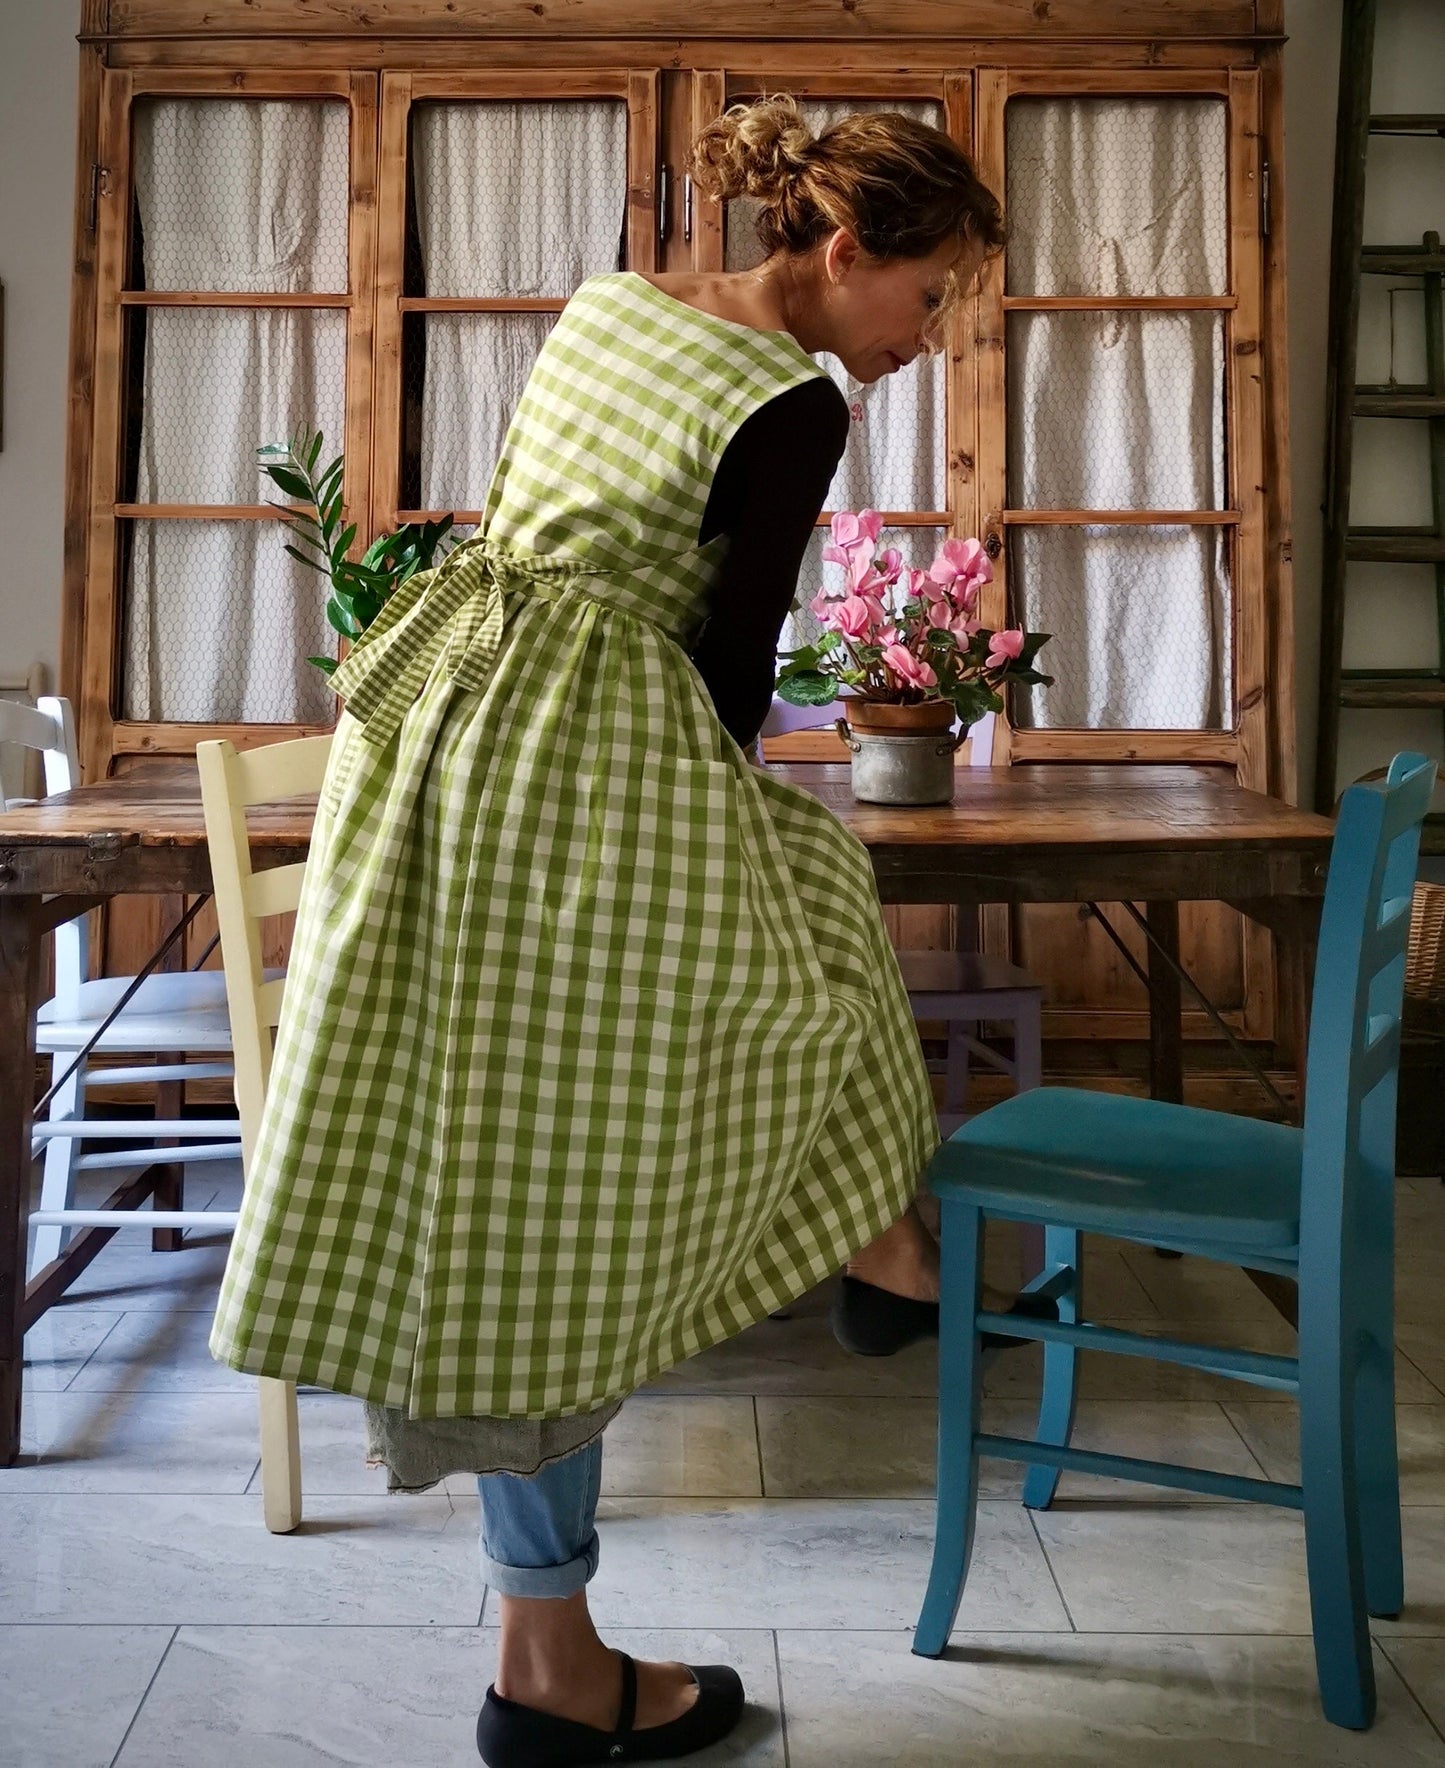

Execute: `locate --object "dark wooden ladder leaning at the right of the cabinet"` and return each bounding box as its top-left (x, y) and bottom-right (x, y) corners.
top-left (1314, 0), bottom-right (1445, 854)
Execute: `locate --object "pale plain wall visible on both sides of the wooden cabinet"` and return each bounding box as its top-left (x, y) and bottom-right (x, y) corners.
top-left (0, 0), bottom-right (1445, 797)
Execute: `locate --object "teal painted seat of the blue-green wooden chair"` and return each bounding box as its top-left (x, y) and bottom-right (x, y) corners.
top-left (929, 1087), bottom-right (1304, 1255)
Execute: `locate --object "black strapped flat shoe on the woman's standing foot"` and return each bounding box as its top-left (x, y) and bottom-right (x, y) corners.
top-left (478, 1651), bottom-right (743, 1768)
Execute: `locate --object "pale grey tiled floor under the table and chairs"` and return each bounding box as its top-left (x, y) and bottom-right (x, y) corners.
top-left (0, 1174), bottom-right (1445, 1768)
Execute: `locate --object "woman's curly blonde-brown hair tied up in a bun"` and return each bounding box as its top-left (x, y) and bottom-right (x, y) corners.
top-left (690, 92), bottom-right (1005, 297)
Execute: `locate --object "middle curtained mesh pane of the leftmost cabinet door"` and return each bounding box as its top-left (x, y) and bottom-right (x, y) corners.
top-left (126, 308), bottom-right (347, 504)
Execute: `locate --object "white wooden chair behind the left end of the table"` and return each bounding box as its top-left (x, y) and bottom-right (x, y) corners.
top-left (0, 698), bottom-right (241, 1275)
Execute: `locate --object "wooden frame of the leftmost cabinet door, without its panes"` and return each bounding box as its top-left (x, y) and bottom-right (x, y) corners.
top-left (80, 67), bottom-right (378, 780)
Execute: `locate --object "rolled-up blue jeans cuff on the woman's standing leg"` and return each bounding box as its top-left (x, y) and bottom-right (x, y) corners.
top-left (478, 1436), bottom-right (601, 1597)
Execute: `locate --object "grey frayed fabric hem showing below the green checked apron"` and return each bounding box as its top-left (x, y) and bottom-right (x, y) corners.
top-left (364, 1400), bottom-right (623, 1492)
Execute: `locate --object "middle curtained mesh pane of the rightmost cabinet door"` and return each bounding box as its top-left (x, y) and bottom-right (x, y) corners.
top-left (1008, 313), bottom-right (1227, 509)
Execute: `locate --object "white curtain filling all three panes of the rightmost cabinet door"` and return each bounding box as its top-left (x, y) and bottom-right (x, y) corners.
top-left (1006, 99), bottom-right (1231, 730)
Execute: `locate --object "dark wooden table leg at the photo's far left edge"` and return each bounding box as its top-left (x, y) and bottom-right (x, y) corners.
top-left (0, 896), bottom-right (39, 1467)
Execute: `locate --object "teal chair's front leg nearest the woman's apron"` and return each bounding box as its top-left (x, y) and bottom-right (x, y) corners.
top-left (913, 1199), bottom-right (983, 1657)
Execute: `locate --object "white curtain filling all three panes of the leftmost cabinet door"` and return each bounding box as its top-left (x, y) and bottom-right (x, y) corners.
top-left (122, 99), bottom-right (348, 723)
